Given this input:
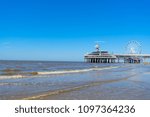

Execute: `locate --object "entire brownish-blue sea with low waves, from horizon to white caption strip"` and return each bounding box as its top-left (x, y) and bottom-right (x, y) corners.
top-left (0, 60), bottom-right (150, 100)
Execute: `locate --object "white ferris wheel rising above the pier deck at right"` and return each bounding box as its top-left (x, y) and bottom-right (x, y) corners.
top-left (126, 40), bottom-right (142, 54)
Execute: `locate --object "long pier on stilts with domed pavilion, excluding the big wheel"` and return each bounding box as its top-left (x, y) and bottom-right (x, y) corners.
top-left (84, 44), bottom-right (150, 63)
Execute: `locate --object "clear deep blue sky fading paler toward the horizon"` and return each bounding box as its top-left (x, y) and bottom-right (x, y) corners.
top-left (0, 0), bottom-right (150, 61)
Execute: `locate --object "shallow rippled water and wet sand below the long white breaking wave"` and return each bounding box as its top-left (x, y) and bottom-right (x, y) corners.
top-left (0, 64), bottom-right (150, 100)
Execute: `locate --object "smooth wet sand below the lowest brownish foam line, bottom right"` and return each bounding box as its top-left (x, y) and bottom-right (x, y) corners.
top-left (41, 75), bottom-right (150, 100)
